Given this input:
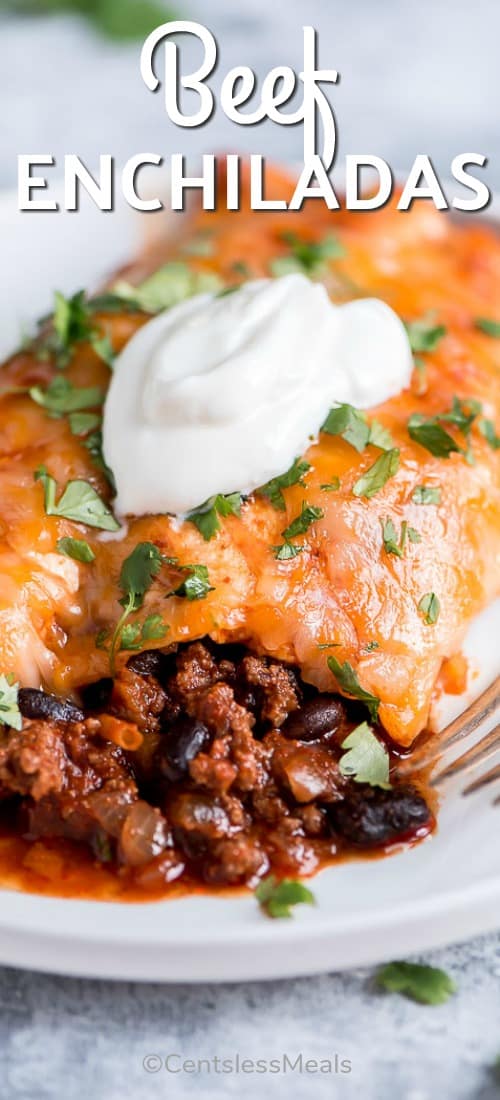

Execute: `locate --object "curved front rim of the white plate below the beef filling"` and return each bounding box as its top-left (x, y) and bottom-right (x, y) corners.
top-left (0, 184), bottom-right (500, 983)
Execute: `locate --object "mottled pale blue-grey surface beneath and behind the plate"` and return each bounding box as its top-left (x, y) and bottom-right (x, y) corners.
top-left (0, 0), bottom-right (500, 1100)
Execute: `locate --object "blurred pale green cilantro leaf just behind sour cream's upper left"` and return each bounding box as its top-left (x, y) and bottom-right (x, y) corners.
top-left (113, 261), bottom-right (223, 314)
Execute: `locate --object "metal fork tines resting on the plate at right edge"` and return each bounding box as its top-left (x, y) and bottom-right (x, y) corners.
top-left (399, 677), bottom-right (500, 804)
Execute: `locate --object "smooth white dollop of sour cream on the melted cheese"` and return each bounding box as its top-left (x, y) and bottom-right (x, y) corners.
top-left (103, 274), bottom-right (412, 515)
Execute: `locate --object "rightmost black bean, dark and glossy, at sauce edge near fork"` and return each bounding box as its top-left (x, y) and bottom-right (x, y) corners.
top-left (329, 787), bottom-right (431, 847)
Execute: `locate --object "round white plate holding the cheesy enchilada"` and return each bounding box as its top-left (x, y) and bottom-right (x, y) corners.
top-left (0, 184), bottom-right (500, 981)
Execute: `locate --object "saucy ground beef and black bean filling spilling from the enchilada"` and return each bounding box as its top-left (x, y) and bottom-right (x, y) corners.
top-left (0, 641), bottom-right (431, 889)
